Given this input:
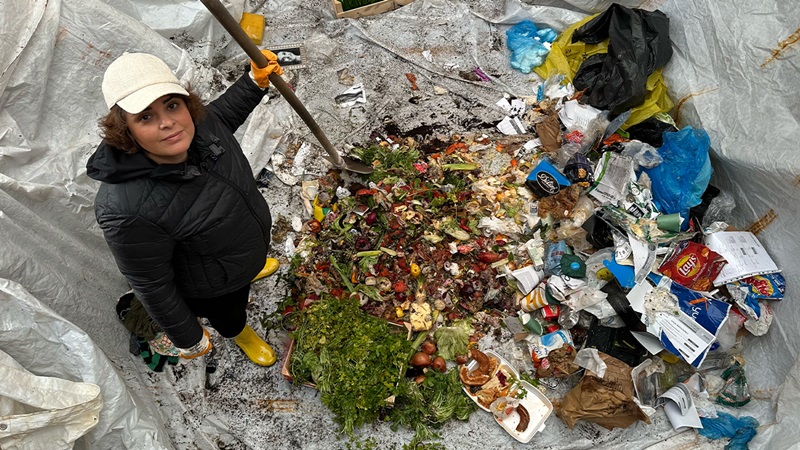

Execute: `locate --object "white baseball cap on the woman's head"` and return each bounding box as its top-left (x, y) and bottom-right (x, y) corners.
top-left (102, 52), bottom-right (189, 114)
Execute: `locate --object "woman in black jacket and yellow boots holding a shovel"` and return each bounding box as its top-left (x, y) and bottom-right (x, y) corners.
top-left (86, 51), bottom-right (282, 366)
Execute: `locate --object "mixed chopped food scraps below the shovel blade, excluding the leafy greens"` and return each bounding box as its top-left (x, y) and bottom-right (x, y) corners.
top-left (292, 136), bottom-right (542, 332)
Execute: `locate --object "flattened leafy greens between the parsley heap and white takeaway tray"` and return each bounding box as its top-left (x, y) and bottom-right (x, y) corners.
top-left (389, 370), bottom-right (477, 448)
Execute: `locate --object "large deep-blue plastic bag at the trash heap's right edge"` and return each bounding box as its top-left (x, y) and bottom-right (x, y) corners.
top-left (645, 126), bottom-right (712, 225)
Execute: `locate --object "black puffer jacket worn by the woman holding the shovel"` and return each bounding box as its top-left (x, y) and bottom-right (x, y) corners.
top-left (86, 75), bottom-right (272, 348)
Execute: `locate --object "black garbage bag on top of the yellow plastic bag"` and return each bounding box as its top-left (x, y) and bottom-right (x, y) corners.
top-left (572, 4), bottom-right (672, 115)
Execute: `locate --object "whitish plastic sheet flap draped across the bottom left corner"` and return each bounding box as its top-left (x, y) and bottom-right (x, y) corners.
top-left (0, 278), bottom-right (172, 449)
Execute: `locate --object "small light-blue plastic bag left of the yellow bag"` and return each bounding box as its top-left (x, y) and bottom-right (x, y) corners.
top-left (506, 20), bottom-right (558, 73)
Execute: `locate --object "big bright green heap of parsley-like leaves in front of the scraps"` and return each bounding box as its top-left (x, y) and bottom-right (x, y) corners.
top-left (291, 297), bottom-right (411, 436)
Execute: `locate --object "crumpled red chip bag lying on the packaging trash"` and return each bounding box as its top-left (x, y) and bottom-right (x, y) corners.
top-left (658, 241), bottom-right (728, 291)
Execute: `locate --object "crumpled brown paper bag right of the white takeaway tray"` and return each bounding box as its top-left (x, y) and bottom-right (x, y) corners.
top-left (556, 352), bottom-right (650, 430)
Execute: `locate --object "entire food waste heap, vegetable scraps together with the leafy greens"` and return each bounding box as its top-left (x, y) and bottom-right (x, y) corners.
top-left (274, 135), bottom-right (546, 442)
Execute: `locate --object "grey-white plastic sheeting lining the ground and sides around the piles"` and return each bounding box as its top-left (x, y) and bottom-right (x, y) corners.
top-left (0, 0), bottom-right (800, 449)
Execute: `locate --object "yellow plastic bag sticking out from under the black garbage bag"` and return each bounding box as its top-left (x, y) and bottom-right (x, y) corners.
top-left (533, 15), bottom-right (674, 130)
